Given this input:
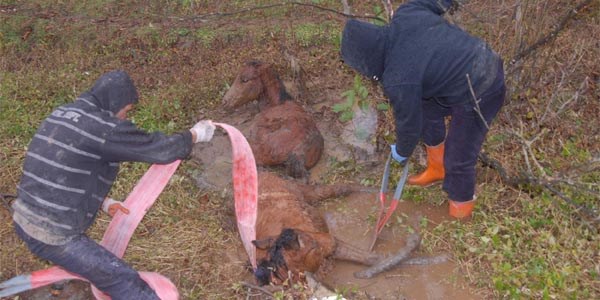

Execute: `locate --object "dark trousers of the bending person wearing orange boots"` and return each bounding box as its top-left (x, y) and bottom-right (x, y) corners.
top-left (421, 81), bottom-right (506, 202)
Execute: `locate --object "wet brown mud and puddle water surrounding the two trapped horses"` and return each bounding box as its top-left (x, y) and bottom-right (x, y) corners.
top-left (192, 104), bottom-right (482, 299)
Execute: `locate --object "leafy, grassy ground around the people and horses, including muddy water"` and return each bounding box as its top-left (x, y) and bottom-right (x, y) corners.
top-left (0, 0), bottom-right (600, 299)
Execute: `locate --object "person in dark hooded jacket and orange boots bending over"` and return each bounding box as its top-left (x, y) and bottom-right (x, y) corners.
top-left (341, 0), bottom-right (506, 218)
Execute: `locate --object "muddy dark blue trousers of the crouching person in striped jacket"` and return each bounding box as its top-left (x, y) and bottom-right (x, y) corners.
top-left (14, 224), bottom-right (159, 300)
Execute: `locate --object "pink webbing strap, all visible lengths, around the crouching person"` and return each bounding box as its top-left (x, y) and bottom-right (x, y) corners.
top-left (0, 123), bottom-right (258, 300)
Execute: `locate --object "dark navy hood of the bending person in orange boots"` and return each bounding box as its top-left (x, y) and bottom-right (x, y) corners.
top-left (341, 19), bottom-right (388, 80)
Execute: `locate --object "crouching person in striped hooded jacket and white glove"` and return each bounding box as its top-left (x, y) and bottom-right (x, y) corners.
top-left (12, 70), bottom-right (215, 300)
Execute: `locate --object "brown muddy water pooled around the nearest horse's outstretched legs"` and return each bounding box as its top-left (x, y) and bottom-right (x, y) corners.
top-left (320, 194), bottom-right (482, 299)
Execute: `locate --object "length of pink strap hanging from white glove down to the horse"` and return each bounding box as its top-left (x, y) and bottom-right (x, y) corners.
top-left (215, 123), bottom-right (258, 269)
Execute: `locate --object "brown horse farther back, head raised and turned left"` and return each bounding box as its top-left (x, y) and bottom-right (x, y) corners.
top-left (223, 61), bottom-right (324, 178)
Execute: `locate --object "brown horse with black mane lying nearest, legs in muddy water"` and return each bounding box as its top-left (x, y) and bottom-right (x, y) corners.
top-left (248, 172), bottom-right (445, 285)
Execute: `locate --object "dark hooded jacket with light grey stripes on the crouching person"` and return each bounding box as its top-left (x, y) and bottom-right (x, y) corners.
top-left (13, 71), bottom-right (192, 245)
